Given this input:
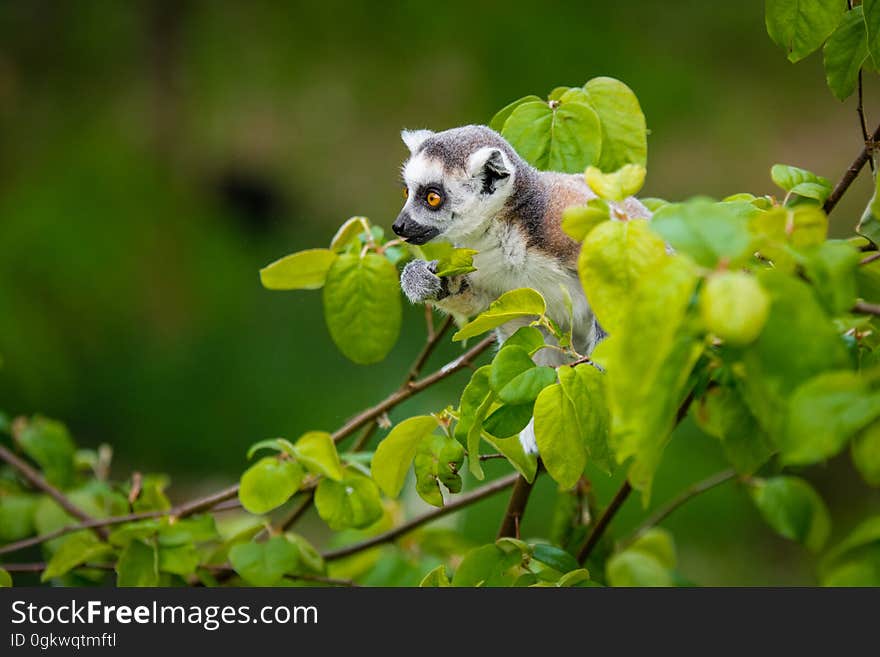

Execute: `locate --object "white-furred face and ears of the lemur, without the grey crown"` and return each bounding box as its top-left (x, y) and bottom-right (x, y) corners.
top-left (394, 130), bottom-right (516, 245)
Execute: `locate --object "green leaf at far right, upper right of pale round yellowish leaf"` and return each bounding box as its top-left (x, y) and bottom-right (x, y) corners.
top-left (802, 240), bottom-right (862, 315)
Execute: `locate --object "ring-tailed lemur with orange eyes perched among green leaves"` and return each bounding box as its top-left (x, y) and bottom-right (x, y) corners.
top-left (392, 125), bottom-right (650, 452)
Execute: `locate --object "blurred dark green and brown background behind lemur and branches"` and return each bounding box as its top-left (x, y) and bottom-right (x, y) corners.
top-left (0, 0), bottom-right (880, 585)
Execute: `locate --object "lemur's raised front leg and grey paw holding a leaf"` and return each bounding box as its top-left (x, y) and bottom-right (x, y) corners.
top-left (400, 260), bottom-right (491, 317)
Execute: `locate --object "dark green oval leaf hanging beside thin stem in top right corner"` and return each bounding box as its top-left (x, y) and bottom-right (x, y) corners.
top-left (822, 5), bottom-right (868, 100)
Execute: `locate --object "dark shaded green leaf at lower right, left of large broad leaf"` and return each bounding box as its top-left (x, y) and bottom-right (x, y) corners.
top-left (693, 387), bottom-right (775, 475)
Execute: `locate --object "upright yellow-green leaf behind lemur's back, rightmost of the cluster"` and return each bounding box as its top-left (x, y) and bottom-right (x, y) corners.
top-left (584, 77), bottom-right (648, 171)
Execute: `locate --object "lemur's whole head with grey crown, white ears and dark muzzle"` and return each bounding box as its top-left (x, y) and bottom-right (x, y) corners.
top-left (392, 125), bottom-right (529, 244)
